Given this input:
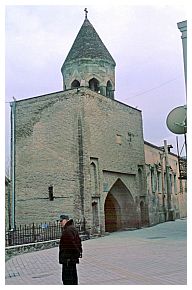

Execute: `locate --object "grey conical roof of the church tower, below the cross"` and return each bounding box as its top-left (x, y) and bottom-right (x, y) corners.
top-left (63, 18), bottom-right (115, 66)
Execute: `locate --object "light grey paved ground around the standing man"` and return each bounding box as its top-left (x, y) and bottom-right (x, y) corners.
top-left (5, 219), bottom-right (187, 285)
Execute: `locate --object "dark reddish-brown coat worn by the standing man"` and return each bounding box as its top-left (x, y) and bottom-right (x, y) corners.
top-left (59, 220), bottom-right (82, 264)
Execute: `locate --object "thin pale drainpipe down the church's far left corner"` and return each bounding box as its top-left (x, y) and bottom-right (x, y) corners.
top-left (10, 99), bottom-right (16, 230)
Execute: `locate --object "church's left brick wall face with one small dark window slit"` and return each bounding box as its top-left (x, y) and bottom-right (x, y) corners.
top-left (16, 91), bottom-right (83, 224)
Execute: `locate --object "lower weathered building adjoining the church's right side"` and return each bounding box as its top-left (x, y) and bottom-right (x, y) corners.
top-left (145, 141), bottom-right (187, 224)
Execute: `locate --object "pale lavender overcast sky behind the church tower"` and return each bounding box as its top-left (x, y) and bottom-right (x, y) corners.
top-left (5, 5), bottom-right (186, 170)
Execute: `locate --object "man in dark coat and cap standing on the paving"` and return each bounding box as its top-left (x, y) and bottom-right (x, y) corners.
top-left (59, 214), bottom-right (82, 285)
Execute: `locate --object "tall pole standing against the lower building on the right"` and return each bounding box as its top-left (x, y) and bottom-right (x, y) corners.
top-left (164, 140), bottom-right (173, 221)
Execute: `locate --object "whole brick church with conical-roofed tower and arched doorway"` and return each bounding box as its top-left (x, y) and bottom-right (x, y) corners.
top-left (8, 14), bottom-right (186, 233)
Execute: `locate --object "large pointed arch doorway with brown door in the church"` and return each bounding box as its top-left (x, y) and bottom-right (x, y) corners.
top-left (104, 179), bottom-right (138, 232)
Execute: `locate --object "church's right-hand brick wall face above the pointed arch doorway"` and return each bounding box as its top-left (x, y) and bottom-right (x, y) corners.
top-left (80, 89), bottom-right (146, 228)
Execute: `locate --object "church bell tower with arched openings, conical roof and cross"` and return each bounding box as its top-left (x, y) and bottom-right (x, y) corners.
top-left (61, 8), bottom-right (116, 99)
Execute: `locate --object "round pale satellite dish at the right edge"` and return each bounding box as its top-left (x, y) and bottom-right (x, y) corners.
top-left (167, 106), bottom-right (187, 134)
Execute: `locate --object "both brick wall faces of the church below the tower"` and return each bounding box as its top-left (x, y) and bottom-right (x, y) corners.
top-left (16, 88), bottom-right (148, 228)
